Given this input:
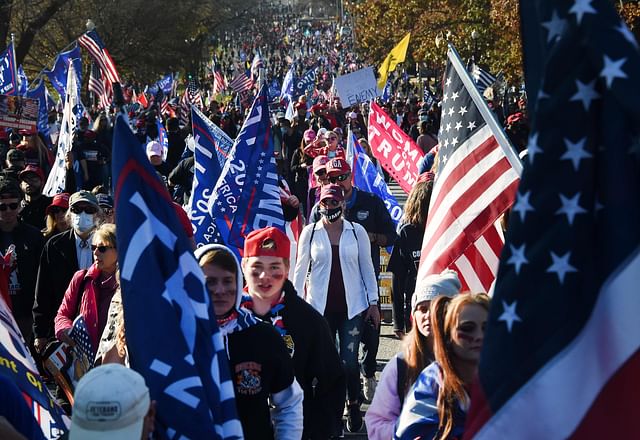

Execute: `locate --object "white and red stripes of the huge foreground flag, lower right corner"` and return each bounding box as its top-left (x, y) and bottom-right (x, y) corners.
top-left (465, 252), bottom-right (640, 440)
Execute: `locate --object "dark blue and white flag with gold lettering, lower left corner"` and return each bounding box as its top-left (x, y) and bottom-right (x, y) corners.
top-left (0, 295), bottom-right (69, 439)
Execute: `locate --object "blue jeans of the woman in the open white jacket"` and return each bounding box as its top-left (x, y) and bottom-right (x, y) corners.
top-left (325, 314), bottom-right (364, 402)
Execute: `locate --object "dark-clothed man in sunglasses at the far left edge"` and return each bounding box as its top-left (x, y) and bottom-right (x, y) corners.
top-left (0, 178), bottom-right (44, 345)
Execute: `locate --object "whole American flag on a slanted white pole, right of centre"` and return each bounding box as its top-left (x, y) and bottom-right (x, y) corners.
top-left (416, 47), bottom-right (522, 292)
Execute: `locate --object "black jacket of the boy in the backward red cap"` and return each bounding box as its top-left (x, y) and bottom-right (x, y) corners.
top-left (258, 280), bottom-right (346, 440)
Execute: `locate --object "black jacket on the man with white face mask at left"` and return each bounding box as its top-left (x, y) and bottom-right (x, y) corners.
top-left (33, 229), bottom-right (79, 338)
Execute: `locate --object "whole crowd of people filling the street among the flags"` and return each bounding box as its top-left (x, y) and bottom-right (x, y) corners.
top-left (0, 1), bottom-right (540, 440)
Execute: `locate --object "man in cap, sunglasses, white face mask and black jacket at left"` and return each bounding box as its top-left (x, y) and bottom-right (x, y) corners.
top-left (33, 191), bottom-right (100, 352)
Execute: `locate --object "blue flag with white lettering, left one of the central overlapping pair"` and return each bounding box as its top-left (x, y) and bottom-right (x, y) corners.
top-left (189, 106), bottom-right (233, 245)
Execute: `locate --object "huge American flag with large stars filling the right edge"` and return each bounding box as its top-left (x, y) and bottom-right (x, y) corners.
top-left (465, 0), bottom-right (640, 439)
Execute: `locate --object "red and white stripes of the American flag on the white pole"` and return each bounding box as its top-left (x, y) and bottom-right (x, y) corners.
top-left (416, 125), bottom-right (520, 292)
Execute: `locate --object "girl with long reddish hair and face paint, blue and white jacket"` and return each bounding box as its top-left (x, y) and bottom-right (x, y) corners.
top-left (394, 293), bottom-right (489, 440)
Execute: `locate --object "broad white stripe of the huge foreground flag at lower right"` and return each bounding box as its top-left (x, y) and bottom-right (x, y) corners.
top-left (465, 249), bottom-right (640, 439)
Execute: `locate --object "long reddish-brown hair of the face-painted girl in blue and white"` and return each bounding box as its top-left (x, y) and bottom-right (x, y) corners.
top-left (429, 293), bottom-right (489, 439)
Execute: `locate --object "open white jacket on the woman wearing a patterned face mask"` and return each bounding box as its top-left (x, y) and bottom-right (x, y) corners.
top-left (293, 220), bottom-right (378, 319)
